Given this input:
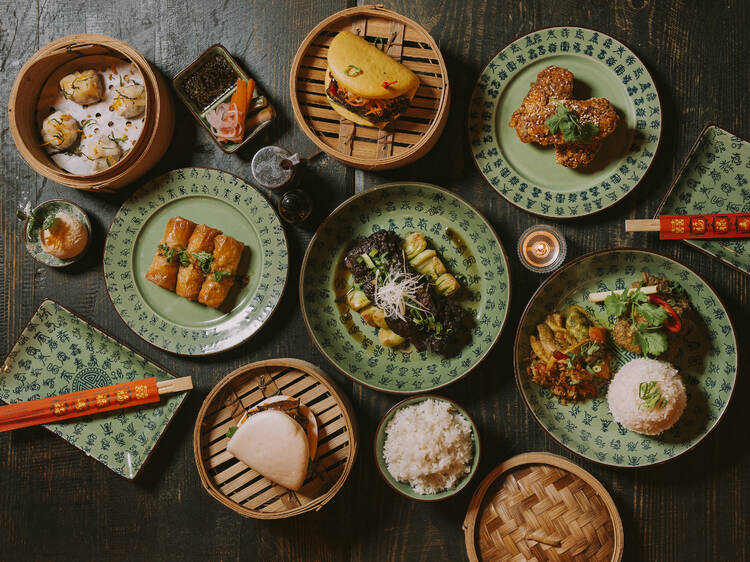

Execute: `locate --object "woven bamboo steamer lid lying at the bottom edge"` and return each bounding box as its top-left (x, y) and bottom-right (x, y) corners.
top-left (463, 453), bottom-right (624, 562)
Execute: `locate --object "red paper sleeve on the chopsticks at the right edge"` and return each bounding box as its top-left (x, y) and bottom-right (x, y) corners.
top-left (659, 213), bottom-right (750, 240)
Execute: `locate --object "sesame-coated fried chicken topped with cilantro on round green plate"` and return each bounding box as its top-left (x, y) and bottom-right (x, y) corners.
top-left (510, 66), bottom-right (620, 168)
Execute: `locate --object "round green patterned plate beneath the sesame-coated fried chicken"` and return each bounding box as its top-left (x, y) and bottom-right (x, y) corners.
top-left (469, 27), bottom-right (662, 219)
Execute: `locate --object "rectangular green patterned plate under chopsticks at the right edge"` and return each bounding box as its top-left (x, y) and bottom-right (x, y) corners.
top-left (657, 125), bottom-right (750, 274)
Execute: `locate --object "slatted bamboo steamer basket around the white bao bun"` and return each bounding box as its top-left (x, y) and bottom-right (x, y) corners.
top-left (193, 359), bottom-right (358, 519)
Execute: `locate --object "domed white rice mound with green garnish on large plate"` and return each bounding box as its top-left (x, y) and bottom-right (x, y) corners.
top-left (607, 358), bottom-right (687, 435)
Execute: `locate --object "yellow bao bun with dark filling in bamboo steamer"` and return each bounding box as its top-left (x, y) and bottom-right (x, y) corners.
top-left (325, 31), bottom-right (419, 129)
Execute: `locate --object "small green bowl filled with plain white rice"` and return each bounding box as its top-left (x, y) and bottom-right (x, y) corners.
top-left (375, 394), bottom-right (480, 501)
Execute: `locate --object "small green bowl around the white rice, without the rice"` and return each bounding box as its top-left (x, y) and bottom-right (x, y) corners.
top-left (374, 394), bottom-right (481, 502)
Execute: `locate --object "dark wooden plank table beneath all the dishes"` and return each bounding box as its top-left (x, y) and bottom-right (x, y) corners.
top-left (0, 0), bottom-right (750, 561)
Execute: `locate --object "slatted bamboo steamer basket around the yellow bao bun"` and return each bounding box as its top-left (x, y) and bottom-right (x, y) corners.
top-left (289, 6), bottom-right (450, 170)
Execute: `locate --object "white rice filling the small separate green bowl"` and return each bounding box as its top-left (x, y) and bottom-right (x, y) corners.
top-left (383, 399), bottom-right (474, 494)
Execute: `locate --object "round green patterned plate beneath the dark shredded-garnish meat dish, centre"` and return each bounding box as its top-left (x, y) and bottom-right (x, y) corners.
top-left (300, 183), bottom-right (510, 393)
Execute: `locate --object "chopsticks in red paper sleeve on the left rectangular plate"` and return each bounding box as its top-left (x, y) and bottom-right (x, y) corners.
top-left (0, 377), bottom-right (193, 432)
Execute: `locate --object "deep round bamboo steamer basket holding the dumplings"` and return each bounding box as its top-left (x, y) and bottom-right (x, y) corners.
top-left (8, 34), bottom-right (174, 192)
